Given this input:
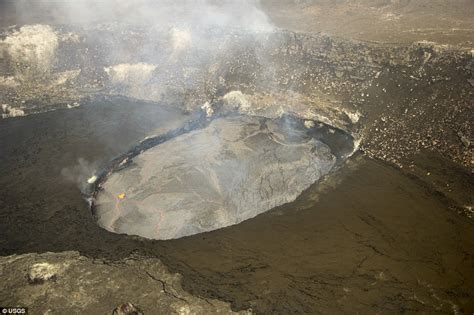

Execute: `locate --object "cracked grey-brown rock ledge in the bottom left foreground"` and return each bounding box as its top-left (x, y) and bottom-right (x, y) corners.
top-left (0, 251), bottom-right (247, 314)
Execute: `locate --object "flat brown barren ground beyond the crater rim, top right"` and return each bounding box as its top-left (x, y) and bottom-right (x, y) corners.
top-left (263, 0), bottom-right (474, 48)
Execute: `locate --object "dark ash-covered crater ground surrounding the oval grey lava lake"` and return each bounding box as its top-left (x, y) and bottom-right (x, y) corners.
top-left (0, 0), bottom-right (474, 313)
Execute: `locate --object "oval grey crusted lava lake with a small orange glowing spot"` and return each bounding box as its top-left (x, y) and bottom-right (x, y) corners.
top-left (93, 115), bottom-right (353, 239)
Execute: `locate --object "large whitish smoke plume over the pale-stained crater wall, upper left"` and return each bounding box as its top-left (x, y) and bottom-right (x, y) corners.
top-left (0, 0), bottom-right (282, 113)
